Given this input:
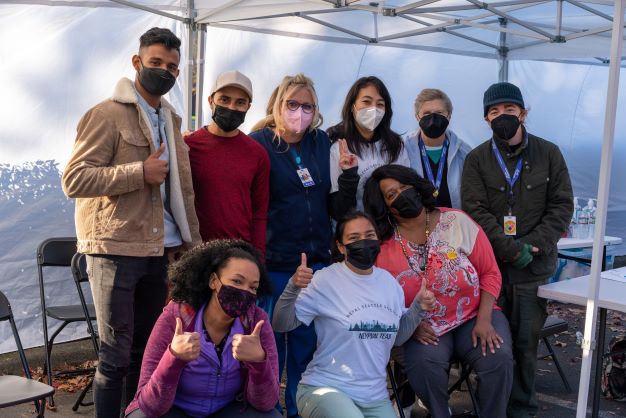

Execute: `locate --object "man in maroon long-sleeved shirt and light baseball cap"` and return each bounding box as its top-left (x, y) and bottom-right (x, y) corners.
top-left (185, 71), bottom-right (270, 254)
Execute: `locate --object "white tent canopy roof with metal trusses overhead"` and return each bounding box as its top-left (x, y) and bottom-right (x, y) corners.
top-left (8, 0), bottom-right (624, 65)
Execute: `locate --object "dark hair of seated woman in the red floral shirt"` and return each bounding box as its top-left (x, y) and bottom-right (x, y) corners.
top-left (363, 164), bottom-right (437, 241)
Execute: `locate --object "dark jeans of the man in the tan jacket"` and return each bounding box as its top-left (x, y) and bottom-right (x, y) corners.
top-left (87, 255), bottom-right (167, 418)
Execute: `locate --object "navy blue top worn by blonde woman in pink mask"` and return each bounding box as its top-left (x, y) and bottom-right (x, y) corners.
top-left (250, 128), bottom-right (331, 272)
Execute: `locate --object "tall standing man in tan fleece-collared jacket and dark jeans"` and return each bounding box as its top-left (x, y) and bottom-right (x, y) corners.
top-left (62, 28), bottom-right (200, 418)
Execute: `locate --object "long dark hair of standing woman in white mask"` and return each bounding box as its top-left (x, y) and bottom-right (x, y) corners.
top-left (326, 76), bottom-right (404, 163)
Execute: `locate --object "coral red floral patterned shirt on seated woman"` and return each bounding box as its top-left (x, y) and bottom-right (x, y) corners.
top-left (376, 208), bottom-right (502, 336)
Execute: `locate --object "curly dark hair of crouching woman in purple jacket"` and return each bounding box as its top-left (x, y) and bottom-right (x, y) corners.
top-left (168, 240), bottom-right (272, 309)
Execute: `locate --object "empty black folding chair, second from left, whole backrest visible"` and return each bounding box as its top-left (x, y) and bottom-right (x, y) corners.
top-left (37, 237), bottom-right (98, 410)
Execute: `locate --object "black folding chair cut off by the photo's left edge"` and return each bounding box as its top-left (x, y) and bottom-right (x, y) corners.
top-left (0, 292), bottom-right (54, 417)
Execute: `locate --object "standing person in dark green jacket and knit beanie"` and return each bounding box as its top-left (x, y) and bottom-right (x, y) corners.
top-left (461, 82), bottom-right (573, 418)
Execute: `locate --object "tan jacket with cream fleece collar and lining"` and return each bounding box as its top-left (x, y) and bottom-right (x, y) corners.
top-left (62, 78), bottom-right (200, 257)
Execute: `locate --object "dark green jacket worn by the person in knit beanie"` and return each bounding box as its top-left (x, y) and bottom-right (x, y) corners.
top-left (461, 131), bottom-right (574, 284)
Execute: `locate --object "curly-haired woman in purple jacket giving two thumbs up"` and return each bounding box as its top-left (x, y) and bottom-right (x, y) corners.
top-left (126, 240), bottom-right (280, 418)
